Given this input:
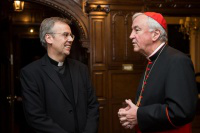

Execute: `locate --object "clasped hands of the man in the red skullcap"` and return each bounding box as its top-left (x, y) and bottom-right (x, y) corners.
top-left (118, 99), bottom-right (138, 129)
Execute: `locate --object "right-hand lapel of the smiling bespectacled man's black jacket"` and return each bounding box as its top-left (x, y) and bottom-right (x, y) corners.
top-left (67, 59), bottom-right (80, 104)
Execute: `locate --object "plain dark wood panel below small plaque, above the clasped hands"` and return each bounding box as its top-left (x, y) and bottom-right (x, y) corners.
top-left (109, 70), bottom-right (142, 99)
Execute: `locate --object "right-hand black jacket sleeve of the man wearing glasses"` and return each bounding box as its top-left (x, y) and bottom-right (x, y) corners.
top-left (83, 67), bottom-right (99, 133)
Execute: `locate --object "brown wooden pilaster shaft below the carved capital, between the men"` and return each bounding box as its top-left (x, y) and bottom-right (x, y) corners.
top-left (89, 12), bottom-right (109, 133)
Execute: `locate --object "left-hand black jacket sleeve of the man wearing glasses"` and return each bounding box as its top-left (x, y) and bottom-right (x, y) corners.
top-left (20, 69), bottom-right (67, 133)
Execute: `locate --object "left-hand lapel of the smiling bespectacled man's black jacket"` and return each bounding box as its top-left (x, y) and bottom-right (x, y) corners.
top-left (42, 54), bottom-right (71, 102)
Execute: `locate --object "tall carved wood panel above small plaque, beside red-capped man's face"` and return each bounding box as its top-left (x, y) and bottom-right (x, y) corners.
top-left (108, 11), bottom-right (144, 66)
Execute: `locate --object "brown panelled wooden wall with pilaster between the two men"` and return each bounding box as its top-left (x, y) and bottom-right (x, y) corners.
top-left (89, 2), bottom-right (145, 133)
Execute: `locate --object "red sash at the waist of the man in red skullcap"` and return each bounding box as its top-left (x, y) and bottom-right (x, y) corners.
top-left (135, 123), bottom-right (192, 133)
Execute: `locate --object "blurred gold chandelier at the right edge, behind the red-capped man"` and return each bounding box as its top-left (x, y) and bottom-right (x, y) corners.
top-left (179, 17), bottom-right (199, 39)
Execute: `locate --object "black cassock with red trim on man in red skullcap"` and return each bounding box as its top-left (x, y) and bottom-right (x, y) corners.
top-left (136, 45), bottom-right (197, 132)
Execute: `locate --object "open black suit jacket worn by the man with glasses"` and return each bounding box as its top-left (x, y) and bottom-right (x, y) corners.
top-left (20, 55), bottom-right (99, 133)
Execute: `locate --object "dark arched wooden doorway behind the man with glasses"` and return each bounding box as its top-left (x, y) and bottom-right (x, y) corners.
top-left (0, 0), bottom-right (89, 133)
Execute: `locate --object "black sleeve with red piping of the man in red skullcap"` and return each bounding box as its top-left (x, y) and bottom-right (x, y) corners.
top-left (137, 56), bottom-right (197, 131)
